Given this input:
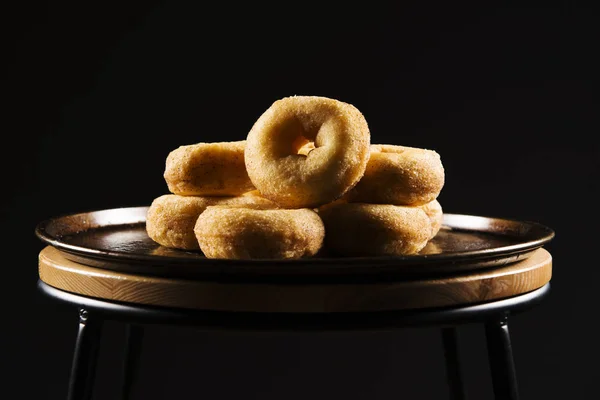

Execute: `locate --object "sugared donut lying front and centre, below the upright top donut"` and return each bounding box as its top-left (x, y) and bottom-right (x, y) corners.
top-left (194, 206), bottom-right (325, 259)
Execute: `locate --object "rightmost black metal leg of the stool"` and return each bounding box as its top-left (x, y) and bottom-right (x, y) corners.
top-left (485, 315), bottom-right (519, 400)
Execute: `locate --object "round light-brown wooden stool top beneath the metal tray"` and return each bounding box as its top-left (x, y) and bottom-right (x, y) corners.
top-left (39, 246), bottom-right (552, 313)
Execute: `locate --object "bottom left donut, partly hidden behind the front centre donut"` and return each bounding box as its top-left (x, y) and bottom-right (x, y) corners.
top-left (146, 194), bottom-right (277, 250)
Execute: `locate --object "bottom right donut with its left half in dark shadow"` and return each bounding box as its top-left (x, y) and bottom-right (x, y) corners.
top-left (319, 202), bottom-right (432, 256)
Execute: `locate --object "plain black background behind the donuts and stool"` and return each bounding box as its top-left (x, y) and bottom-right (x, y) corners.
top-left (0, 2), bottom-right (600, 400)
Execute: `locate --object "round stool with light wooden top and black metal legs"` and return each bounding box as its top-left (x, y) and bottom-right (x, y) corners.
top-left (38, 246), bottom-right (552, 400)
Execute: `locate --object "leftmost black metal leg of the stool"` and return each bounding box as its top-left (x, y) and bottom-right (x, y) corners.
top-left (67, 308), bottom-right (103, 400)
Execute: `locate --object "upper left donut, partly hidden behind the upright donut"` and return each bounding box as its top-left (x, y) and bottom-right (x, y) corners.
top-left (163, 140), bottom-right (255, 196)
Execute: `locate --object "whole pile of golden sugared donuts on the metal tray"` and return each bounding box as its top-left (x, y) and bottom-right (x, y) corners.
top-left (146, 96), bottom-right (444, 259)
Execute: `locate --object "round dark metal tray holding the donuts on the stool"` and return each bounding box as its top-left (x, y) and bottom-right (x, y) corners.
top-left (35, 207), bottom-right (554, 283)
